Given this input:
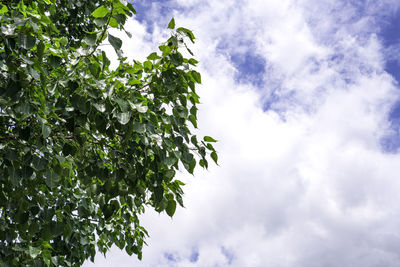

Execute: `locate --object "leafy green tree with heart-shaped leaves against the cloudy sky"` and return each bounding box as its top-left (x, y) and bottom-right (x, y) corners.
top-left (0, 0), bottom-right (217, 266)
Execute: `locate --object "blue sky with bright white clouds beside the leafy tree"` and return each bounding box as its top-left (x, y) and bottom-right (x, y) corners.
top-left (84, 0), bottom-right (400, 267)
